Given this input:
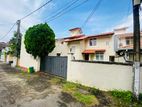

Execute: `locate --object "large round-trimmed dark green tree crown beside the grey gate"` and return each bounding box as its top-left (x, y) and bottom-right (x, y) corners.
top-left (24, 23), bottom-right (55, 58)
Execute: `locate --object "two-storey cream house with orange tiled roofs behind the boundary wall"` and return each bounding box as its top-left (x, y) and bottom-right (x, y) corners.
top-left (64, 28), bottom-right (115, 61)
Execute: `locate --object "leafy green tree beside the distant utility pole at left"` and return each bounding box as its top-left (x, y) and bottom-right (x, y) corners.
top-left (8, 32), bottom-right (22, 57)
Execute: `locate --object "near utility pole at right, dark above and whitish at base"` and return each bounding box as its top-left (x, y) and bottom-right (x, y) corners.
top-left (133, 0), bottom-right (141, 99)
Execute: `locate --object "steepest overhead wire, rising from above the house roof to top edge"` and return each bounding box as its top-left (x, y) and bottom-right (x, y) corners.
top-left (81, 0), bottom-right (103, 28)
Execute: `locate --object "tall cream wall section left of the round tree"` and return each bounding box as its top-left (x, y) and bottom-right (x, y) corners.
top-left (20, 36), bottom-right (40, 71)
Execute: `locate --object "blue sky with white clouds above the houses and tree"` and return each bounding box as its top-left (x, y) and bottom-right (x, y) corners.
top-left (0, 0), bottom-right (142, 42)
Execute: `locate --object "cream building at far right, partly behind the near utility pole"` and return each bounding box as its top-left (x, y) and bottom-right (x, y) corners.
top-left (115, 28), bottom-right (142, 62)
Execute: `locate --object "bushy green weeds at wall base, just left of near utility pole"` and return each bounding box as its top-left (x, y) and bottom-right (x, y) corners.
top-left (111, 90), bottom-right (133, 103)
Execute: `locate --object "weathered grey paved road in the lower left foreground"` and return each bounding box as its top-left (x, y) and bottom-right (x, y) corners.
top-left (0, 62), bottom-right (83, 107)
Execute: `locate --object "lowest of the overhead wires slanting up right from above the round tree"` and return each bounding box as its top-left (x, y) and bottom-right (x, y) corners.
top-left (47, 0), bottom-right (89, 22)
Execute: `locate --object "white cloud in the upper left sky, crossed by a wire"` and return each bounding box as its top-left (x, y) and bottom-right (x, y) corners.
top-left (0, 0), bottom-right (53, 42)
